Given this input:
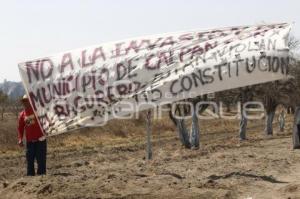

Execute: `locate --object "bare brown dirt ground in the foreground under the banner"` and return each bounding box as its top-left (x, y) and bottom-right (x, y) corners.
top-left (0, 114), bottom-right (300, 199)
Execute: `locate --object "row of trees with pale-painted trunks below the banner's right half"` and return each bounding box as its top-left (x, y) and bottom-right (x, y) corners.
top-left (169, 58), bottom-right (300, 149)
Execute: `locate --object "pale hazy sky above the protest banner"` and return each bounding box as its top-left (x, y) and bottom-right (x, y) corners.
top-left (0, 0), bottom-right (300, 82)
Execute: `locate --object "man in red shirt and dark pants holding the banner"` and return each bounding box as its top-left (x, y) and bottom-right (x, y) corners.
top-left (18, 95), bottom-right (47, 176)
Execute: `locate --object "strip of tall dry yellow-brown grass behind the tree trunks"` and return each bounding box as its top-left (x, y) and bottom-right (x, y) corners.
top-left (0, 109), bottom-right (292, 153)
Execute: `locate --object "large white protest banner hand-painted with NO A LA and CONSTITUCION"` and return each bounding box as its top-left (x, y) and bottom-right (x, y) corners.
top-left (19, 23), bottom-right (290, 136)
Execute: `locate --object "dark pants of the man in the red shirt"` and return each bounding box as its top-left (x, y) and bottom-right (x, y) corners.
top-left (26, 140), bottom-right (47, 176)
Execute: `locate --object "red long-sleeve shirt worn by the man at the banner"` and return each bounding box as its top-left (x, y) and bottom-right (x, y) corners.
top-left (18, 108), bottom-right (44, 142)
